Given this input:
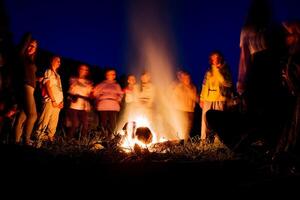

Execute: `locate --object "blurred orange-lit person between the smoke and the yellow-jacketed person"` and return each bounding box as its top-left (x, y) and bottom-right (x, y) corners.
top-left (173, 70), bottom-right (197, 142)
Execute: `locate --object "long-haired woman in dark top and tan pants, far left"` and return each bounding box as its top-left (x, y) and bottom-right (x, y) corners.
top-left (14, 33), bottom-right (38, 145)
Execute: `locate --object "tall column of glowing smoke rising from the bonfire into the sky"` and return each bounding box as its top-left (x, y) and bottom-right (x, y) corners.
top-left (123, 1), bottom-right (183, 140)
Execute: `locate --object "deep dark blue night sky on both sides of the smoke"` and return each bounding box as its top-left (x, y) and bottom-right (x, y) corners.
top-left (5, 0), bottom-right (300, 88)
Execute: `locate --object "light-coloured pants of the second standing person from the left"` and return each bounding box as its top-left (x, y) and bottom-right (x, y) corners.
top-left (36, 101), bottom-right (60, 138)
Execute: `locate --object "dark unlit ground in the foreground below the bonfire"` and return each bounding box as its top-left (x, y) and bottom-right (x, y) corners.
top-left (0, 137), bottom-right (300, 195)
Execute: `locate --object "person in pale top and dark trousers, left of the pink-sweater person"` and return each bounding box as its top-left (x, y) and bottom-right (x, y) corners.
top-left (66, 64), bottom-right (93, 139)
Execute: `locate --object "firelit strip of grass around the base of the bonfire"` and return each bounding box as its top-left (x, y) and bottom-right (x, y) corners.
top-left (34, 126), bottom-right (236, 163)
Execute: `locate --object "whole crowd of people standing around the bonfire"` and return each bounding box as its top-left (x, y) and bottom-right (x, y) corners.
top-left (0, 1), bottom-right (300, 172)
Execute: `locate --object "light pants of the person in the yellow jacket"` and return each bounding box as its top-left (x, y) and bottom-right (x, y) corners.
top-left (201, 101), bottom-right (225, 140)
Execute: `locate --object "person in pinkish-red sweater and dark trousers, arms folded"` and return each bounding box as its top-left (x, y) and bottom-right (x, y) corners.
top-left (93, 69), bottom-right (123, 139)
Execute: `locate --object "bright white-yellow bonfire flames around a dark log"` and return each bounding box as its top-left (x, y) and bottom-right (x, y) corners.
top-left (121, 116), bottom-right (166, 152)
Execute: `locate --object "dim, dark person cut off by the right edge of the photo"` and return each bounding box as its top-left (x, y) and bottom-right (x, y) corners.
top-left (273, 21), bottom-right (300, 173)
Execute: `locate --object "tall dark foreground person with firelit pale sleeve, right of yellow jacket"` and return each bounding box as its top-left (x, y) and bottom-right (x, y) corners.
top-left (237, 0), bottom-right (283, 145)
